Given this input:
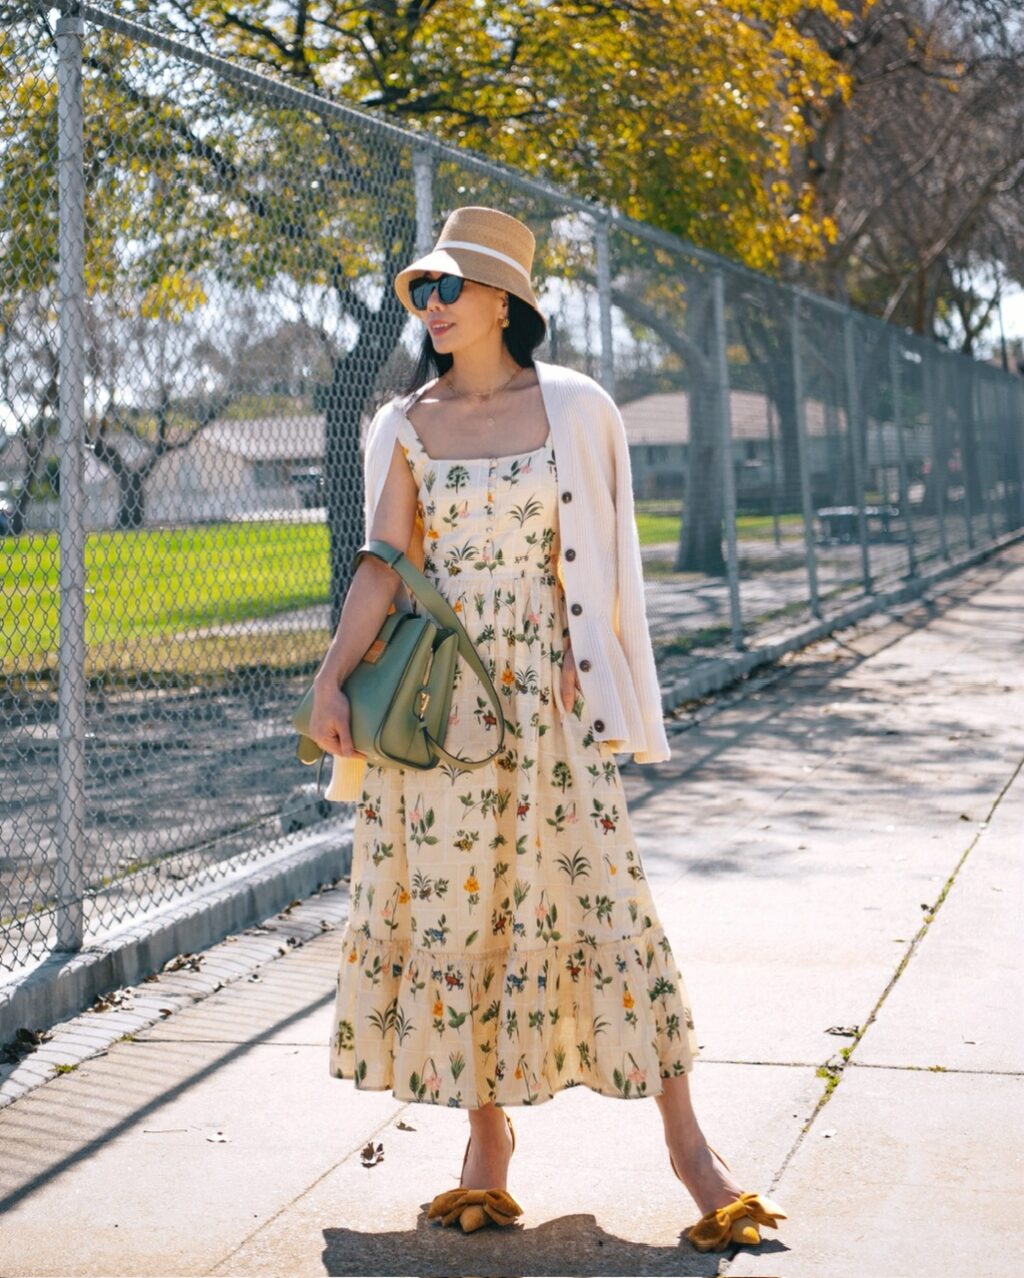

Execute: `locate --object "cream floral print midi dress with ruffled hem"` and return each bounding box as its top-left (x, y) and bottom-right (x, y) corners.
top-left (330, 418), bottom-right (698, 1108)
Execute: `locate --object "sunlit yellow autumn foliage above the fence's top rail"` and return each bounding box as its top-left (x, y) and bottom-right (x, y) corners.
top-left (176, 0), bottom-right (849, 268)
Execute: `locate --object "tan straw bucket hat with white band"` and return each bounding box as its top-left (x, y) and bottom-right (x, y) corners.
top-left (395, 204), bottom-right (547, 323)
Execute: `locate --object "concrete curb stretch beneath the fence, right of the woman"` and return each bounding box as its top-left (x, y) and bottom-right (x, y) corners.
top-left (661, 529), bottom-right (1024, 714)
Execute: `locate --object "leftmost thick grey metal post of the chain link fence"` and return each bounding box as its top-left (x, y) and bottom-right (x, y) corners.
top-left (56, 9), bottom-right (86, 950)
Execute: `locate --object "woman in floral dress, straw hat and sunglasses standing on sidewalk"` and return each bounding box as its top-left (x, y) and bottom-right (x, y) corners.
top-left (309, 207), bottom-right (781, 1250)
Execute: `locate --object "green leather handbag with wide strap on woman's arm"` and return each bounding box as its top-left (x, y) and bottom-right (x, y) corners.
top-left (291, 541), bottom-right (505, 786)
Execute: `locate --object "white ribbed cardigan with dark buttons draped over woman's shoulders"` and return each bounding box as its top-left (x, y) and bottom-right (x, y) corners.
top-left (326, 360), bottom-right (671, 801)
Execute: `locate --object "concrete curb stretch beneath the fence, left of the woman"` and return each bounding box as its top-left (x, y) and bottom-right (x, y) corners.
top-left (0, 820), bottom-right (352, 1043)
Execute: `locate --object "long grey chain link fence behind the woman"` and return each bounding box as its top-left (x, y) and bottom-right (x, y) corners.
top-left (0, 5), bottom-right (1024, 971)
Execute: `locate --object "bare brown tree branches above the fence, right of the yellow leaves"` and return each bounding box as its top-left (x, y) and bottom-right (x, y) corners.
top-left (803, 0), bottom-right (1024, 353)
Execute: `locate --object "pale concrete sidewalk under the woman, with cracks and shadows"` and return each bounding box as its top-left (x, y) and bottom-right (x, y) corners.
top-left (0, 548), bottom-right (1024, 1278)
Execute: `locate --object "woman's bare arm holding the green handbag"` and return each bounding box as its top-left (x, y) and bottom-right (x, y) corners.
top-left (309, 443), bottom-right (417, 755)
